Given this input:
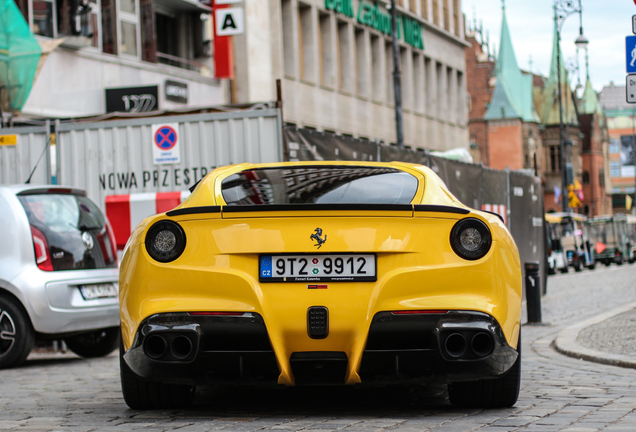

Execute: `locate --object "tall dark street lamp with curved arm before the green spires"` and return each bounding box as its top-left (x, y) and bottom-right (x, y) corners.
top-left (554, 0), bottom-right (589, 212)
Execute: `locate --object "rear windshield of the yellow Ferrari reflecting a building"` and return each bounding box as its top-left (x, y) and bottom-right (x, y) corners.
top-left (221, 166), bottom-right (418, 205)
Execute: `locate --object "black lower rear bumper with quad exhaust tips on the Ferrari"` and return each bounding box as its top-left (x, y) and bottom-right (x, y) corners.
top-left (123, 311), bottom-right (518, 385)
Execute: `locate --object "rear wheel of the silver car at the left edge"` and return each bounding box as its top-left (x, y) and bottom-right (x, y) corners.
top-left (0, 295), bottom-right (35, 369)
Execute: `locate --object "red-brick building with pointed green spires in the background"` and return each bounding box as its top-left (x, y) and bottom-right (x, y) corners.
top-left (466, 7), bottom-right (611, 216)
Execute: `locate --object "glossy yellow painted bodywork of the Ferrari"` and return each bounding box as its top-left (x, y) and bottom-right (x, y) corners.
top-left (120, 162), bottom-right (522, 385)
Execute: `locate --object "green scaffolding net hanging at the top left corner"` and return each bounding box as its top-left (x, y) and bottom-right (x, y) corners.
top-left (0, 0), bottom-right (42, 111)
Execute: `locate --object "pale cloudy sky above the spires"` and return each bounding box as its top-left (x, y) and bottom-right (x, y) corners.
top-left (462, 0), bottom-right (636, 91)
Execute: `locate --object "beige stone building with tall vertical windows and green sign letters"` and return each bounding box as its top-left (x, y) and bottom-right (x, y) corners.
top-left (233, 0), bottom-right (468, 150)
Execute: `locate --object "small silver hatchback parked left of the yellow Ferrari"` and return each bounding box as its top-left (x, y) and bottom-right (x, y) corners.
top-left (0, 185), bottom-right (119, 369)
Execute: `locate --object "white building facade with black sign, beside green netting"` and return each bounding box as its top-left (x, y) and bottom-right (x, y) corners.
top-left (11, 0), bottom-right (229, 118)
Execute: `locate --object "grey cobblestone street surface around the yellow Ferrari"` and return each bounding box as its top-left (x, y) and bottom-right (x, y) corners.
top-left (0, 266), bottom-right (636, 432)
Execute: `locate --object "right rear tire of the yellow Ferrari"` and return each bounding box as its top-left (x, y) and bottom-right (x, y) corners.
top-left (448, 334), bottom-right (521, 408)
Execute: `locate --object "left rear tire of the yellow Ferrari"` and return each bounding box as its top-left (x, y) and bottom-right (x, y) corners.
top-left (119, 341), bottom-right (195, 410)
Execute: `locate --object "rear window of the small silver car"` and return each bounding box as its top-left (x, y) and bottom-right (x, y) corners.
top-left (18, 194), bottom-right (117, 270)
